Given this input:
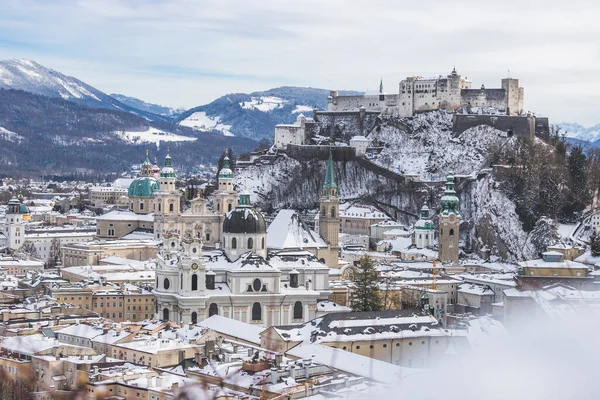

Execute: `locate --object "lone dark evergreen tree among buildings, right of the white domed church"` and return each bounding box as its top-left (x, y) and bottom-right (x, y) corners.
top-left (350, 257), bottom-right (381, 311)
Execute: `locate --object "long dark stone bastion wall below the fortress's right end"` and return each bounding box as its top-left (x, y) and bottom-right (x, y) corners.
top-left (453, 114), bottom-right (535, 139)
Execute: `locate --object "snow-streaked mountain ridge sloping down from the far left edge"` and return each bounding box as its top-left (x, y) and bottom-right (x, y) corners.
top-left (0, 59), bottom-right (166, 120)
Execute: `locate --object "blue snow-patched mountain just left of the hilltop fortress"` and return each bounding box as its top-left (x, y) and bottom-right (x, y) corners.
top-left (177, 86), bottom-right (359, 140)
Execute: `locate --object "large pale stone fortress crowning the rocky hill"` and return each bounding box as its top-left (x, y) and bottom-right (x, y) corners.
top-left (327, 68), bottom-right (524, 117)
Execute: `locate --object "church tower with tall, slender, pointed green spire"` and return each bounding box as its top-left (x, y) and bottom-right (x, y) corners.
top-left (317, 146), bottom-right (340, 268)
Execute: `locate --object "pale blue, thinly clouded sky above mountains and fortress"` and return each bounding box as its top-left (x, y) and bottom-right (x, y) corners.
top-left (0, 0), bottom-right (600, 126)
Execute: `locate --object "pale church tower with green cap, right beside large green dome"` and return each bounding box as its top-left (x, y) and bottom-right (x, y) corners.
top-left (154, 150), bottom-right (181, 239)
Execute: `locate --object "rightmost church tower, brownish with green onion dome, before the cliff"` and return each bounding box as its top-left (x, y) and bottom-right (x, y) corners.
top-left (438, 175), bottom-right (460, 264)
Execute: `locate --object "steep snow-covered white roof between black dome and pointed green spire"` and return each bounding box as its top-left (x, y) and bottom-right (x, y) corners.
top-left (267, 210), bottom-right (327, 249)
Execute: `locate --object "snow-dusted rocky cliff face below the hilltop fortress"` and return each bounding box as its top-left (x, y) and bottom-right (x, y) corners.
top-left (236, 113), bottom-right (535, 261)
